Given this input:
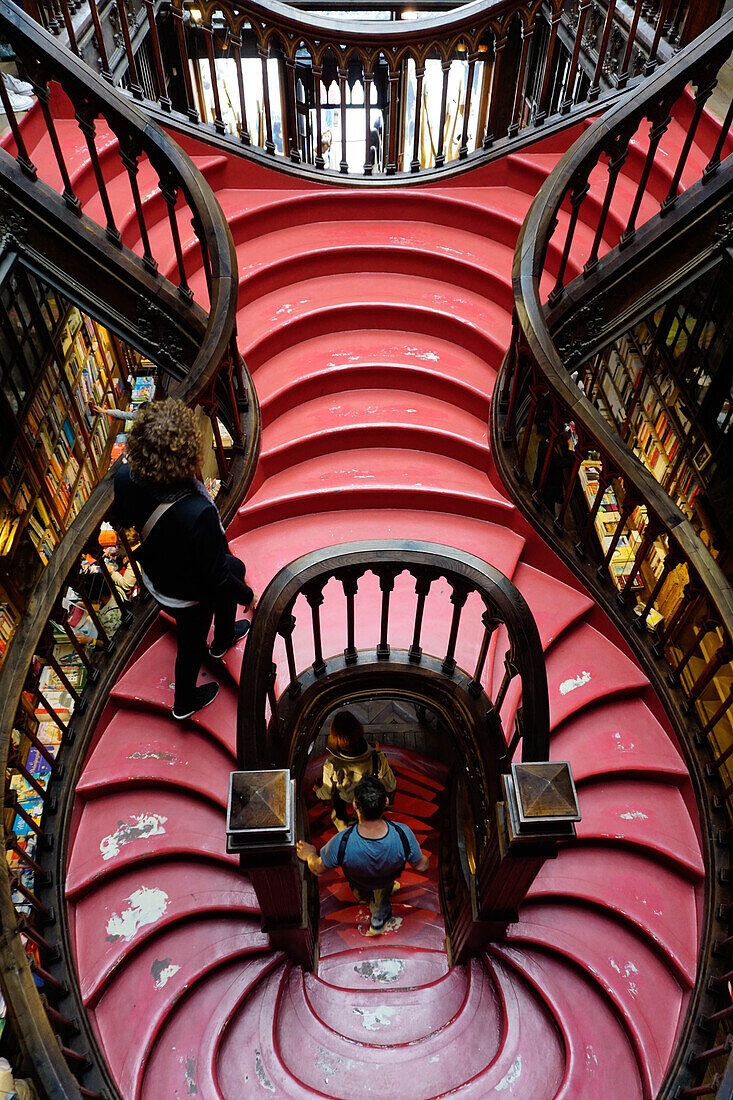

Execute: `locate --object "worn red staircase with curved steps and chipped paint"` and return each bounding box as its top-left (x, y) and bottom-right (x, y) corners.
top-left (14, 92), bottom-right (713, 1100)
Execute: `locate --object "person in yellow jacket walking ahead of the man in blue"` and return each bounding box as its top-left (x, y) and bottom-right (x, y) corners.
top-left (315, 711), bottom-right (397, 832)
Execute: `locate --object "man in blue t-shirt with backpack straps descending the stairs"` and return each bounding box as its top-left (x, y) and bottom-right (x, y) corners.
top-left (296, 776), bottom-right (428, 935)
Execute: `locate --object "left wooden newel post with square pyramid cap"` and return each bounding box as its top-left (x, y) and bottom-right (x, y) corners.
top-left (227, 769), bottom-right (318, 970)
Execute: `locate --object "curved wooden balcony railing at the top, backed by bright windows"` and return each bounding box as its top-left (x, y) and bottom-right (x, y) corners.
top-left (18, 0), bottom-right (721, 178)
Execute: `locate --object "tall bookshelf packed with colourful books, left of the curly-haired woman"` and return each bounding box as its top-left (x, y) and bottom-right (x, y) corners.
top-left (0, 261), bottom-right (134, 662)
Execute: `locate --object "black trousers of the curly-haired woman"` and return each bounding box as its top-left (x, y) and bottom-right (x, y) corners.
top-left (171, 554), bottom-right (254, 714)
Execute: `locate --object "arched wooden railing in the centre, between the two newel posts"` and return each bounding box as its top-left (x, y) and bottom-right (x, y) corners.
top-left (237, 539), bottom-right (549, 965)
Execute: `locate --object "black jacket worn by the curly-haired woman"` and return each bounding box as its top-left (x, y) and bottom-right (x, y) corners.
top-left (113, 464), bottom-right (251, 604)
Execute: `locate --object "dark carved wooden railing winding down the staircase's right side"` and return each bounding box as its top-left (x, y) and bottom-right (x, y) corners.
top-left (492, 15), bottom-right (733, 1098)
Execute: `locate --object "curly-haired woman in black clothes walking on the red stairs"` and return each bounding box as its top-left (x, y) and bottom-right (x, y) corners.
top-left (114, 398), bottom-right (254, 719)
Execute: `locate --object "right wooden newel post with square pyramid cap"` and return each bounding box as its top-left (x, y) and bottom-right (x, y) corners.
top-left (451, 761), bottom-right (580, 961)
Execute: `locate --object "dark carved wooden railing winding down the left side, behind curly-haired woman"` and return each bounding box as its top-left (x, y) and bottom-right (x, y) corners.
top-left (0, 0), bottom-right (259, 1098)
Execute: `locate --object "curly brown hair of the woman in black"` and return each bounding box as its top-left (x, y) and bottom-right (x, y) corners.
top-left (125, 397), bottom-right (204, 485)
